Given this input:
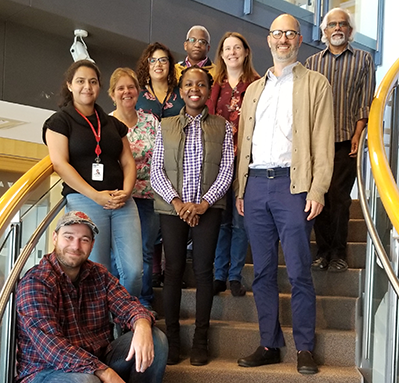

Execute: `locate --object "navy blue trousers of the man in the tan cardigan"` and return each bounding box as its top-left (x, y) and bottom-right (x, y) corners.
top-left (244, 177), bottom-right (316, 351)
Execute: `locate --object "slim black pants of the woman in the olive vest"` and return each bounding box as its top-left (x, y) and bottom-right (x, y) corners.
top-left (160, 208), bottom-right (222, 341)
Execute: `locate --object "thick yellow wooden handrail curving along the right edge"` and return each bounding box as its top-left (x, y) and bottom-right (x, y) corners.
top-left (368, 59), bottom-right (399, 233)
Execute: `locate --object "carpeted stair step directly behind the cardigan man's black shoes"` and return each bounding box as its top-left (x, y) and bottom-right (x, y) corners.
top-left (157, 319), bottom-right (356, 371)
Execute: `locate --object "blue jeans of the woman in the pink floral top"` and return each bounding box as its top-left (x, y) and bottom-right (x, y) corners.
top-left (134, 198), bottom-right (160, 307)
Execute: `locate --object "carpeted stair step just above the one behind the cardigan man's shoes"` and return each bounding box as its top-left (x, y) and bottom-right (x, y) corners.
top-left (153, 289), bottom-right (357, 330)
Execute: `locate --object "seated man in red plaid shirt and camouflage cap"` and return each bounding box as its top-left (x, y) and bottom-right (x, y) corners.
top-left (16, 211), bottom-right (168, 383)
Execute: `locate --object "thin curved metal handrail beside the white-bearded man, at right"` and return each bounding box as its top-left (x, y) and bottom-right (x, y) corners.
top-left (357, 129), bottom-right (399, 296)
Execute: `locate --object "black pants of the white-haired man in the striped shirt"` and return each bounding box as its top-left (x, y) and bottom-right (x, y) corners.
top-left (314, 141), bottom-right (357, 261)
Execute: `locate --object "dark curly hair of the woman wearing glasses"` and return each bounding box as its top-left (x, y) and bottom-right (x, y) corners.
top-left (136, 41), bottom-right (177, 93)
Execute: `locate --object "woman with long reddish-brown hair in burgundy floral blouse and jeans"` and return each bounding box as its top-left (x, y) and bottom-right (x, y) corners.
top-left (207, 32), bottom-right (260, 297)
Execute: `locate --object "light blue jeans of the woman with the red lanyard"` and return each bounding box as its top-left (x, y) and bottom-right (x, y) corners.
top-left (65, 193), bottom-right (143, 297)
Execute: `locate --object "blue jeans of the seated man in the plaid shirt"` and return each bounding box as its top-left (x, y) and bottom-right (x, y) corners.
top-left (32, 327), bottom-right (168, 383)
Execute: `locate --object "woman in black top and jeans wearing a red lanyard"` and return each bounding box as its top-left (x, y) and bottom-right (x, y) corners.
top-left (43, 60), bottom-right (143, 296)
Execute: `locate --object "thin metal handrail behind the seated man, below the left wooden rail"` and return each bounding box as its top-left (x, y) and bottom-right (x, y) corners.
top-left (0, 198), bottom-right (66, 318)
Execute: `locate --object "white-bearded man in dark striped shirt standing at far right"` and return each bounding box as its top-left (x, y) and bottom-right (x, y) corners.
top-left (305, 8), bottom-right (375, 272)
